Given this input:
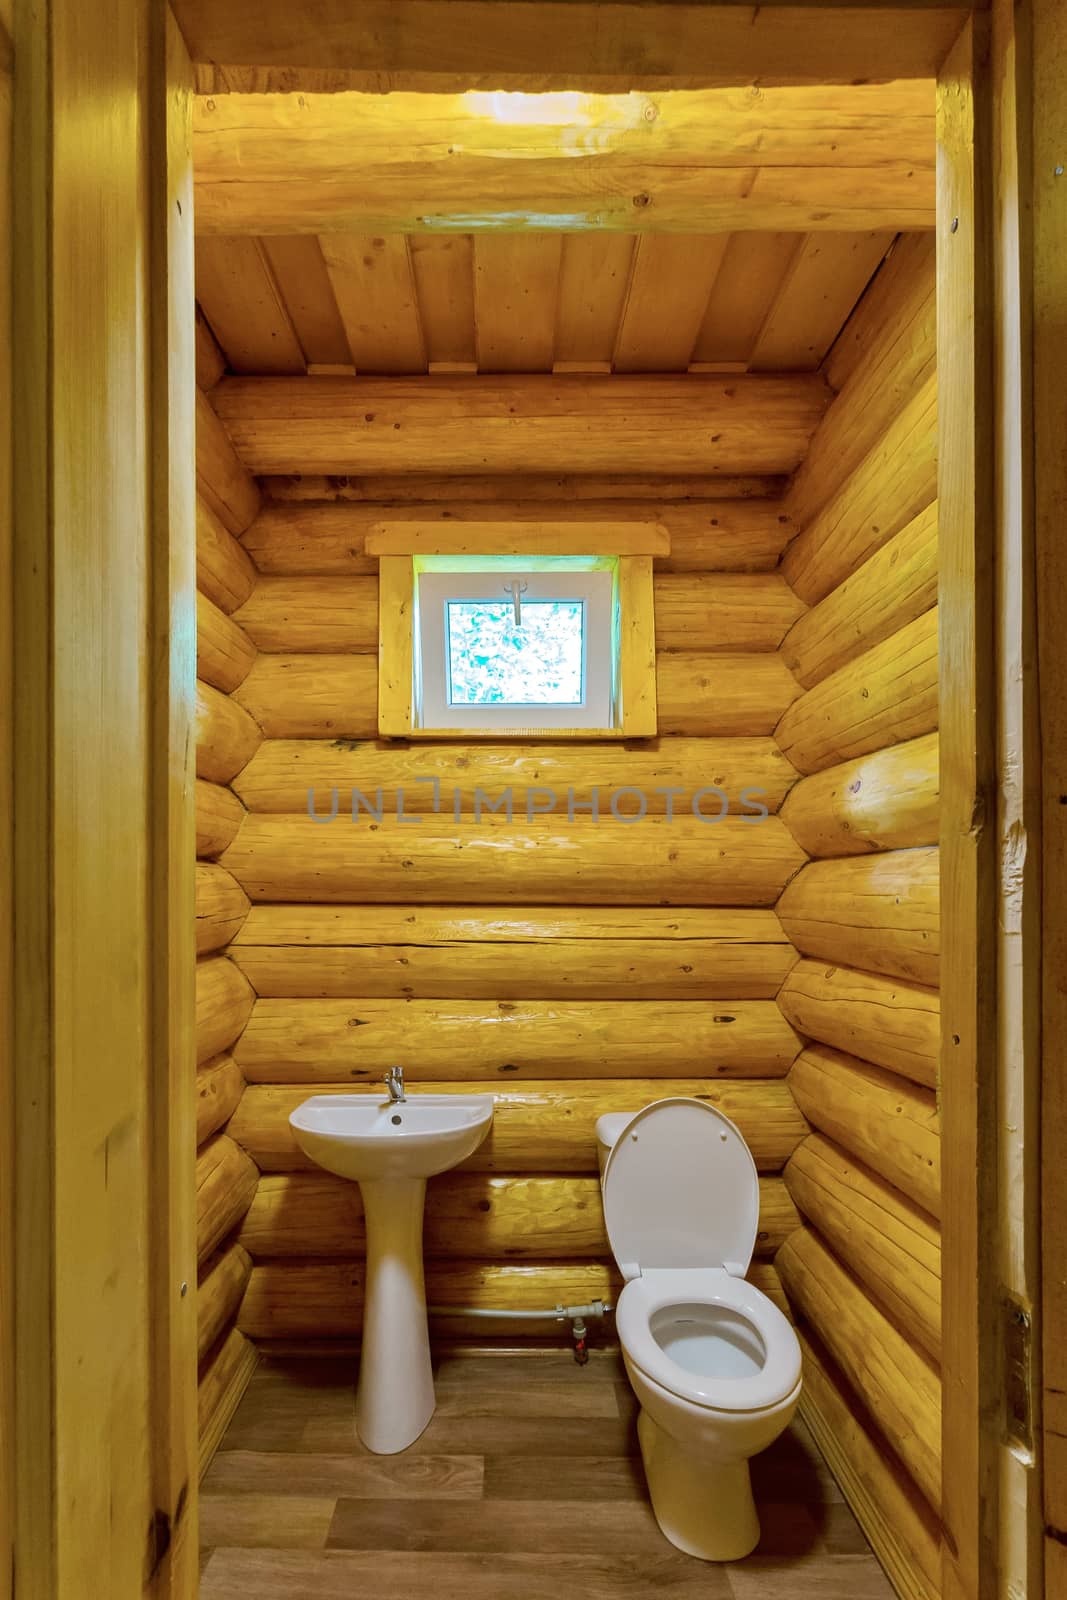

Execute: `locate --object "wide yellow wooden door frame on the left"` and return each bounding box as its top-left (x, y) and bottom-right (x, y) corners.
top-left (7, 0), bottom-right (198, 1600)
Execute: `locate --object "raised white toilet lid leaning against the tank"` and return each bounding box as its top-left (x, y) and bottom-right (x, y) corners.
top-left (603, 1099), bottom-right (760, 1277)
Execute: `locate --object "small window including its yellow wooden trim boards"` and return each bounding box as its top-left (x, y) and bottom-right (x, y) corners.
top-left (365, 522), bottom-right (670, 739)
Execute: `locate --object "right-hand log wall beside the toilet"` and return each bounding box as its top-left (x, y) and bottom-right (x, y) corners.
top-left (776, 228), bottom-right (941, 1600)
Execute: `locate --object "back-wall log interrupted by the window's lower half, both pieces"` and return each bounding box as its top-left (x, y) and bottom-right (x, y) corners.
top-left (234, 651), bottom-right (800, 739)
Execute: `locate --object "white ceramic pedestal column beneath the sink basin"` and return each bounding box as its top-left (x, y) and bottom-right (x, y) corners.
top-left (355, 1178), bottom-right (434, 1456)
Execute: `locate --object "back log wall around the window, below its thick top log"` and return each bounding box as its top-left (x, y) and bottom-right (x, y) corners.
top-left (212, 457), bottom-right (806, 1339)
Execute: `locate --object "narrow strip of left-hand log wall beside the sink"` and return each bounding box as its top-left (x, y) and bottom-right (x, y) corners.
top-left (195, 380), bottom-right (262, 1470)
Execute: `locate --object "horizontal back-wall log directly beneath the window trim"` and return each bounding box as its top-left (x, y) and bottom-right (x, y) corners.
top-left (234, 738), bottom-right (797, 818)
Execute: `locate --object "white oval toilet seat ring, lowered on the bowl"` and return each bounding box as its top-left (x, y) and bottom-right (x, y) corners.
top-left (616, 1267), bottom-right (800, 1414)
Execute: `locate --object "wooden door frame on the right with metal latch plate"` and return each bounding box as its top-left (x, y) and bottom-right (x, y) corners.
top-left (937, 0), bottom-right (1067, 1600)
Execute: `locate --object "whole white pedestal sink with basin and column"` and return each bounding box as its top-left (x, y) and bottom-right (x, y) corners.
top-left (290, 1094), bottom-right (493, 1456)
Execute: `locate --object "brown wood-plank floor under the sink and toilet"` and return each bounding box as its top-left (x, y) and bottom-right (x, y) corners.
top-left (200, 1350), bottom-right (893, 1600)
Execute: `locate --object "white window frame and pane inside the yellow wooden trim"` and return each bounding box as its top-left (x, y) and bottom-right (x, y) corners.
top-left (416, 563), bottom-right (616, 730)
